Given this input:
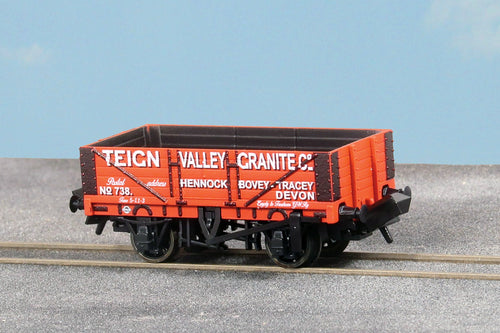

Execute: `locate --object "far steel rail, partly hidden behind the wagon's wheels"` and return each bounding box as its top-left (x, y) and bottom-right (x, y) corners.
top-left (0, 242), bottom-right (500, 265)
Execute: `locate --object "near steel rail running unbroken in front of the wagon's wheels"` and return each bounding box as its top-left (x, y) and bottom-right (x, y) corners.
top-left (0, 258), bottom-right (500, 281)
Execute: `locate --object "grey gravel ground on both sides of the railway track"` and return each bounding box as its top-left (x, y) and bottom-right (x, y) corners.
top-left (0, 158), bottom-right (500, 332)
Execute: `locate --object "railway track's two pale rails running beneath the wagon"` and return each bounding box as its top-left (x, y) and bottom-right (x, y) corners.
top-left (0, 242), bottom-right (500, 281)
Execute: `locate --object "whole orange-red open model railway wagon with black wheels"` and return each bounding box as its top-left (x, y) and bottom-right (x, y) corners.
top-left (70, 125), bottom-right (411, 267)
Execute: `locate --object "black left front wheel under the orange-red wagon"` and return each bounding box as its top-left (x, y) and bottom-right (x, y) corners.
top-left (130, 224), bottom-right (179, 263)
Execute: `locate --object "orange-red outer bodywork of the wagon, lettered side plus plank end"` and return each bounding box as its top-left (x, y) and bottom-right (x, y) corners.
top-left (85, 127), bottom-right (394, 223)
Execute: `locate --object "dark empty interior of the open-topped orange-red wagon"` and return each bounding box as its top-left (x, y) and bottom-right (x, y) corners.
top-left (89, 125), bottom-right (378, 151)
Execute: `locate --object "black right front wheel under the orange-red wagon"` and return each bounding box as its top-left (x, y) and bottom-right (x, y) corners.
top-left (266, 227), bottom-right (321, 268)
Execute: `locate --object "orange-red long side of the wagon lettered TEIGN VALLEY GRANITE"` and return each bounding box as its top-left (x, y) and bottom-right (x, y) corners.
top-left (89, 147), bottom-right (320, 219)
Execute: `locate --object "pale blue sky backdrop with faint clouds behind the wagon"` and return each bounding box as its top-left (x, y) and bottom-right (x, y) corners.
top-left (0, 0), bottom-right (500, 164)
